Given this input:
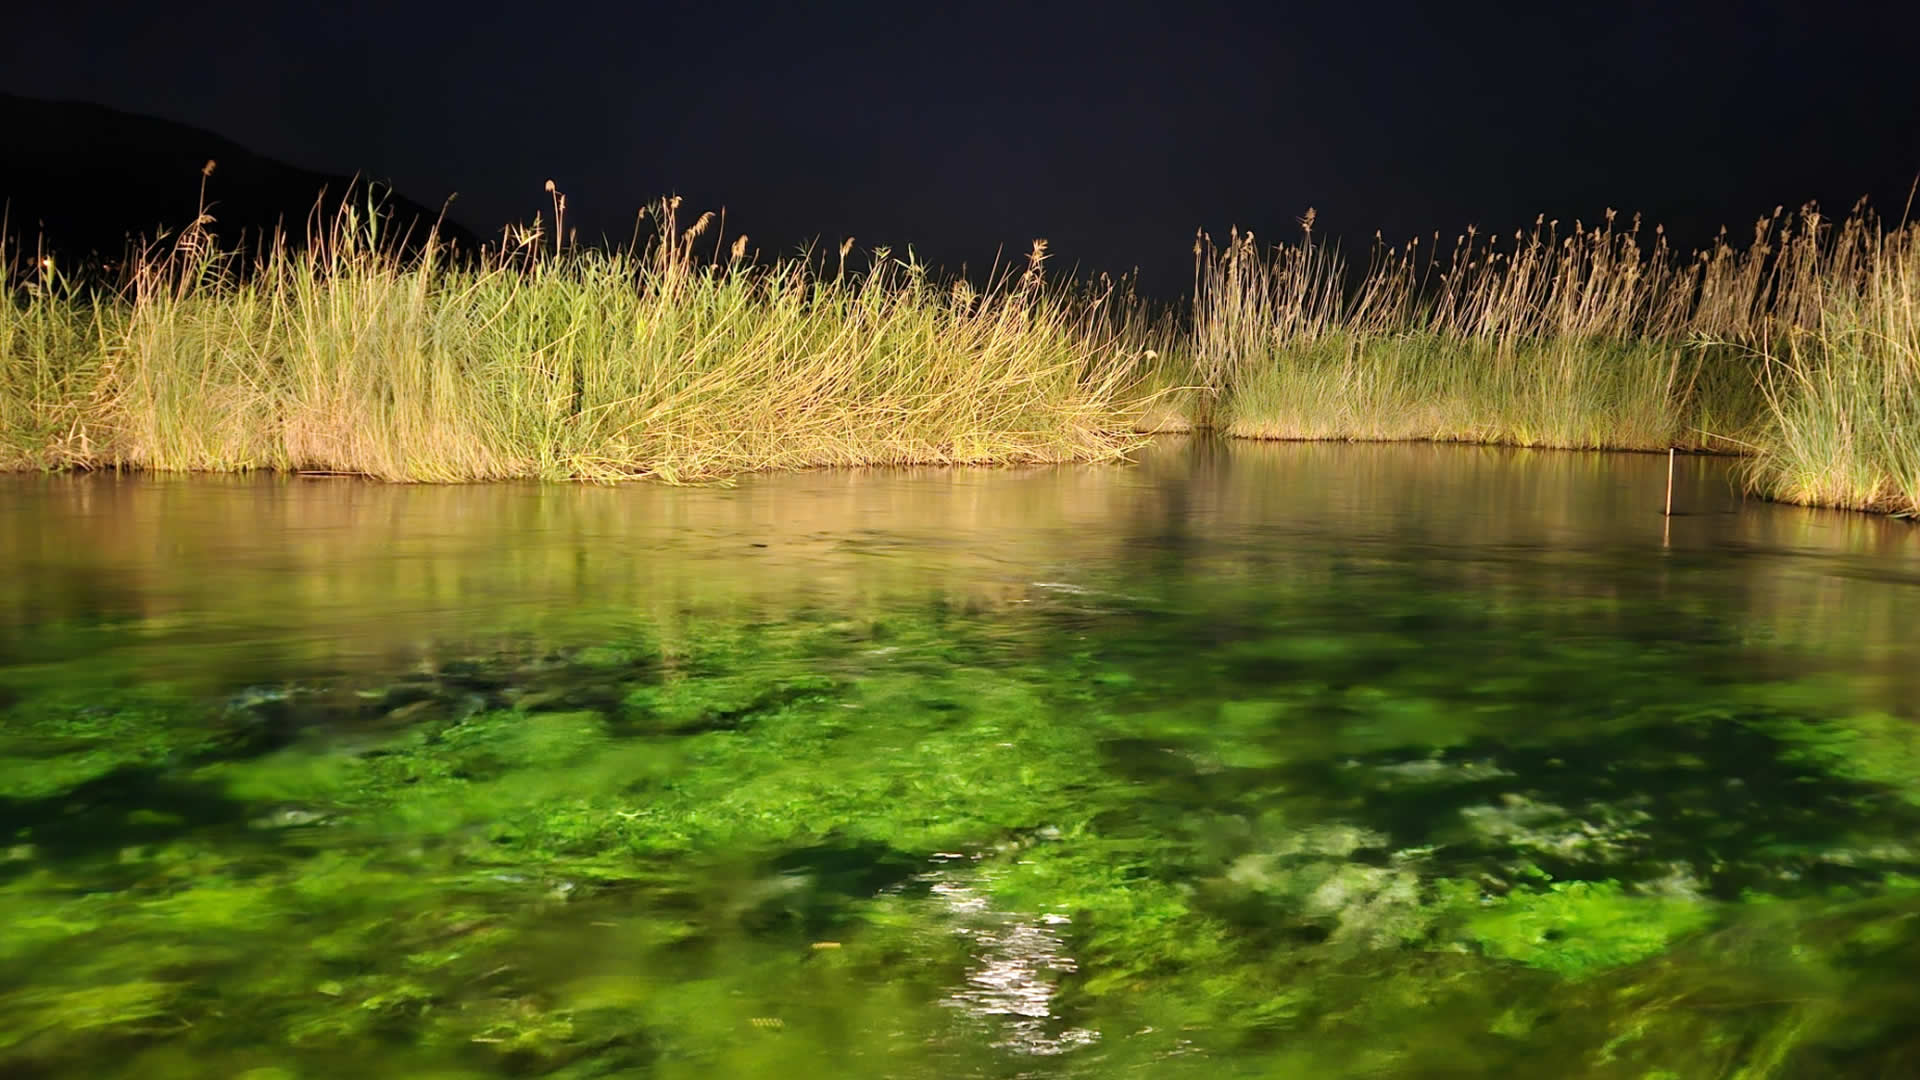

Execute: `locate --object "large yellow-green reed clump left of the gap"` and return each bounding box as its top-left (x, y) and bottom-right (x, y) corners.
top-left (0, 194), bottom-right (1140, 480)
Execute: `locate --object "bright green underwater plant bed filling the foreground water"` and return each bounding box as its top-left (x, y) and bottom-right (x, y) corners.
top-left (0, 573), bottom-right (1920, 1080)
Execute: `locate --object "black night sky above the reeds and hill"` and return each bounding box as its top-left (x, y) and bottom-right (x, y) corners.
top-left (0, 0), bottom-right (1920, 294)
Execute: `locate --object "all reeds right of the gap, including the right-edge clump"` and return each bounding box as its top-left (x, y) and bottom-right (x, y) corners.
top-left (1192, 208), bottom-right (1920, 513)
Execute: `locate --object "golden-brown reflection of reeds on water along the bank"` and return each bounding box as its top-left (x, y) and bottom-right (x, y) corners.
top-left (0, 440), bottom-right (1920, 691)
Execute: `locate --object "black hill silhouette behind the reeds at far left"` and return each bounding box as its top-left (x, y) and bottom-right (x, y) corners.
top-left (0, 94), bottom-right (478, 258)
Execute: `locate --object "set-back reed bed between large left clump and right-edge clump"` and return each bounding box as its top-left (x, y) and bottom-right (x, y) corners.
top-left (1194, 211), bottom-right (1761, 450)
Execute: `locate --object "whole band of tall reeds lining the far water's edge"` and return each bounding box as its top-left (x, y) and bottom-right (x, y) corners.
top-left (0, 175), bottom-right (1920, 513)
